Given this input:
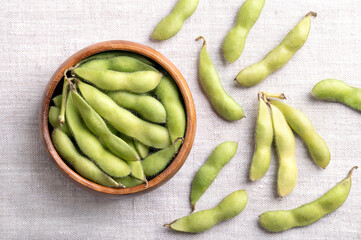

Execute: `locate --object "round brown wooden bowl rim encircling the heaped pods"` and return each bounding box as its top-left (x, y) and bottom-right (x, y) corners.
top-left (40, 41), bottom-right (196, 195)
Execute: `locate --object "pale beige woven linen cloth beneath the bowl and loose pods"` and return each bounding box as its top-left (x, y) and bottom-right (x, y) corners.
top-left (0, 0), bottom-right (361, 239)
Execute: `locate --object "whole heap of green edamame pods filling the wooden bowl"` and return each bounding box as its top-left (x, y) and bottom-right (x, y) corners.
top-left (49, 51), bottom-right (186, 188)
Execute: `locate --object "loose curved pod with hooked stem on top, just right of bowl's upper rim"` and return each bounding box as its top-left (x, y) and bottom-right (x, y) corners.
top-left (197, 36), bottom-right (244, 121)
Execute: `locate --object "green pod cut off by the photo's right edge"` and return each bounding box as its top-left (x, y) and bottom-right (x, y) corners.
top-left (312, 79), bottom-right (361, 111)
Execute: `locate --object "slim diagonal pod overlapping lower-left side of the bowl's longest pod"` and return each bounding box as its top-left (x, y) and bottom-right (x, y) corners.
top-left (70, 89), bottom-right (140, 161)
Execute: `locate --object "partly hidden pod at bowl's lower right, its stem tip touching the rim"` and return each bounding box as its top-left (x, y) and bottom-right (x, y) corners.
top-left (142, 138), bottom-right (181, 177)
